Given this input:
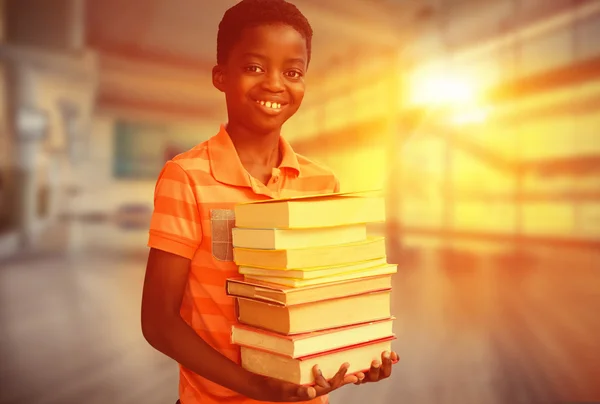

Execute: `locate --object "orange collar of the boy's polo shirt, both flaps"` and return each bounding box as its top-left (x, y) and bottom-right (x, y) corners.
top-left (208, 125), bottom-right (300, 187)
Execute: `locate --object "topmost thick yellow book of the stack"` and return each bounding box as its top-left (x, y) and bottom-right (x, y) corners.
top-left (234, 194), bottom-right (385, 229)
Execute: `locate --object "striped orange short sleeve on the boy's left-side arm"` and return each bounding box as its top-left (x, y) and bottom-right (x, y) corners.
top-left (148, 161), bottom-right (202, 259)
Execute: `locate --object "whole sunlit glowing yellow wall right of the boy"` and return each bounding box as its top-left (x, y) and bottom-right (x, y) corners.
top-left (286, 0), bottom-right (600, 258)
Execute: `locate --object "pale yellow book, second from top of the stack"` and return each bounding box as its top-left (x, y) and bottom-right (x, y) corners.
top-left (232, 224), bottom-right (367, 250)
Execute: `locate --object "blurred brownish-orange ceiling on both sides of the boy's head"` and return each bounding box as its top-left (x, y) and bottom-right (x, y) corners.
top-left (86, 0), bottom-right (433, 118)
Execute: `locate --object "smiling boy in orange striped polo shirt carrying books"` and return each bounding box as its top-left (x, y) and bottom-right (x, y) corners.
top-left (142, 0), bottom-right (397, 404)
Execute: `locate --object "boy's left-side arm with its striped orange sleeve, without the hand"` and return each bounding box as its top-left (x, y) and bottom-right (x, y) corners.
top-left (141, 161), bottom-right (272, 397)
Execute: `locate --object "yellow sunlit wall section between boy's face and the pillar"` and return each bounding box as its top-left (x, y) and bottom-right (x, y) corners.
top-left (283, 55), bottom-right (398, 192)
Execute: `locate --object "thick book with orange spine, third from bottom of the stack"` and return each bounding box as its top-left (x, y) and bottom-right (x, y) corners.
top-left (236, 289), bottom-right (391, 335)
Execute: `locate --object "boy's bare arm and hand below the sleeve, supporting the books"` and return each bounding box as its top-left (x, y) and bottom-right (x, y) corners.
top-left (142, 249), bottom-right (352, 402)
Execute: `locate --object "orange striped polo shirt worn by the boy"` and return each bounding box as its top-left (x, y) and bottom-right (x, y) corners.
top-left (148, 126), bottom-right (339, 404)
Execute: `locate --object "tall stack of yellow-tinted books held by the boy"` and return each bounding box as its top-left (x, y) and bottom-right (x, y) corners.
top-left (227, 194), bottom-right (396, 384)
